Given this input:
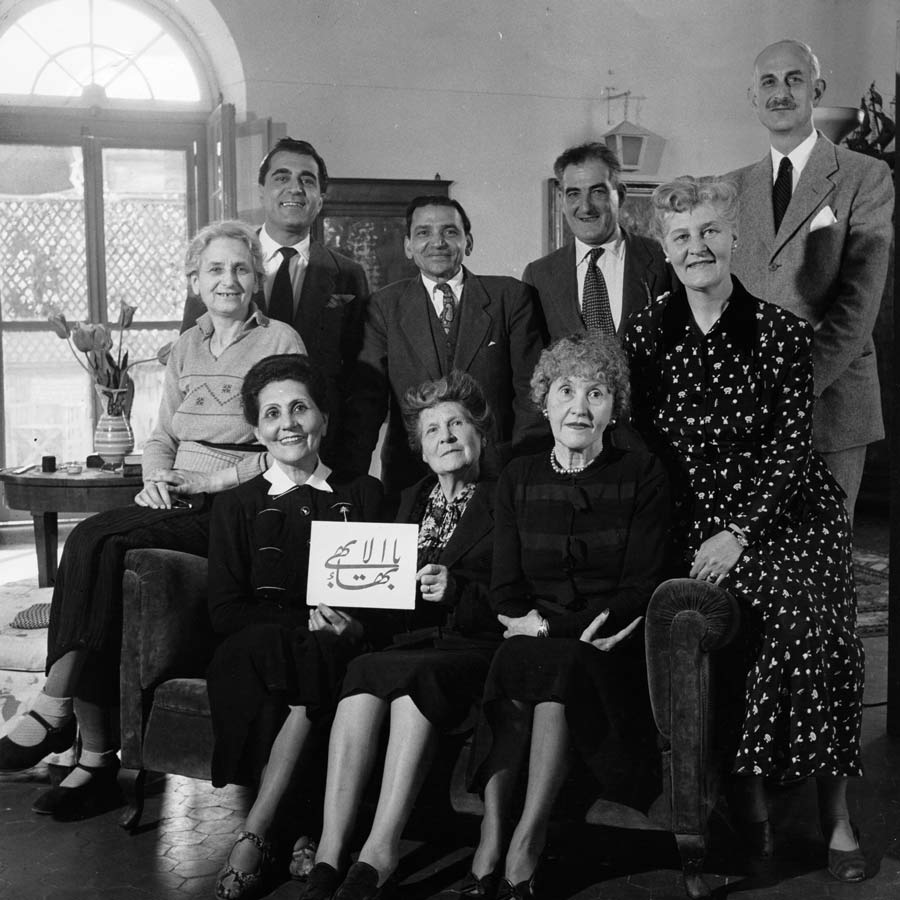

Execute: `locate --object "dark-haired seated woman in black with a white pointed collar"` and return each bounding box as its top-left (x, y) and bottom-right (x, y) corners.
top-left (207, 354), bottom-right (382, 898)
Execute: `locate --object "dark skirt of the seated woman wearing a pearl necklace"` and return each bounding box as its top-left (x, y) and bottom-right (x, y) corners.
top-left (469, 632), bottom-right (659, 811)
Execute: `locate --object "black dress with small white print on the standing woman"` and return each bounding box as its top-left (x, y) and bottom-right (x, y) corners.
top-left (625, 279), bottom-right (864, 776)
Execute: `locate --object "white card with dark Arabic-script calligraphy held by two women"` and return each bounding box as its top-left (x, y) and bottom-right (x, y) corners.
top-left (306, 522), bottom-right (419, 609)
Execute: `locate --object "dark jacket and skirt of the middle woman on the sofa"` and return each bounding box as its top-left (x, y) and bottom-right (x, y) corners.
top-left (341, 476), bottom-right (501, 733)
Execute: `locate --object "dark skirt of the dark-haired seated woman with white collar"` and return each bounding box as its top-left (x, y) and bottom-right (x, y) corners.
top-left (206, 623), bottom-right (361, 787)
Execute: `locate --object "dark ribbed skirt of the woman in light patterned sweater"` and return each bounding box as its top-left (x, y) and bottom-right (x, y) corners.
top-left (47, 501), bottom-right (209, 705)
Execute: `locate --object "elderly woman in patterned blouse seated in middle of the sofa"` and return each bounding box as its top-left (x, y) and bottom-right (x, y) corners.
top-left (300, 371), bottom-right (501, 900)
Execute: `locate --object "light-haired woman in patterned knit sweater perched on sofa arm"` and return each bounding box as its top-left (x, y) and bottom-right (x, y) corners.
top-left (0, 221), bottom-right (304, 818)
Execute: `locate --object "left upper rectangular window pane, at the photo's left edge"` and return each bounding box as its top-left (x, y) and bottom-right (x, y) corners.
top-left (0, 144), bottom-right (88, 322)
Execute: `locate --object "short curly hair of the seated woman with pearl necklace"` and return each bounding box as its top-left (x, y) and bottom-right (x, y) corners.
top-left (531, 334), bottom-right (631, 420)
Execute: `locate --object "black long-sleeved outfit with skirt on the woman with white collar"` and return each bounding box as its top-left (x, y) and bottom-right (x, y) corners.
top-left (207, 475), bottom-right (389, 787)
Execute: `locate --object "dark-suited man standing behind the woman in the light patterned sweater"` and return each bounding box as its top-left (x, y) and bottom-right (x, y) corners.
top-left (181, 138), bottom-right (369, 466)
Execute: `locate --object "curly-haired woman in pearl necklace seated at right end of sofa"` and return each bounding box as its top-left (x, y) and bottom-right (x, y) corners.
top-left (460, 335), bottom-right (669, 898)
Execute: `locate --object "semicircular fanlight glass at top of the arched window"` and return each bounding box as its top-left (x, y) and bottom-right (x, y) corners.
top-left (0, 0), bottom-right (210, 108)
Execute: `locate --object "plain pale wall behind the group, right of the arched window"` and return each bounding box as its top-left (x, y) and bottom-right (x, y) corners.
top-left (209, 0), bottom-right (900, 275)
